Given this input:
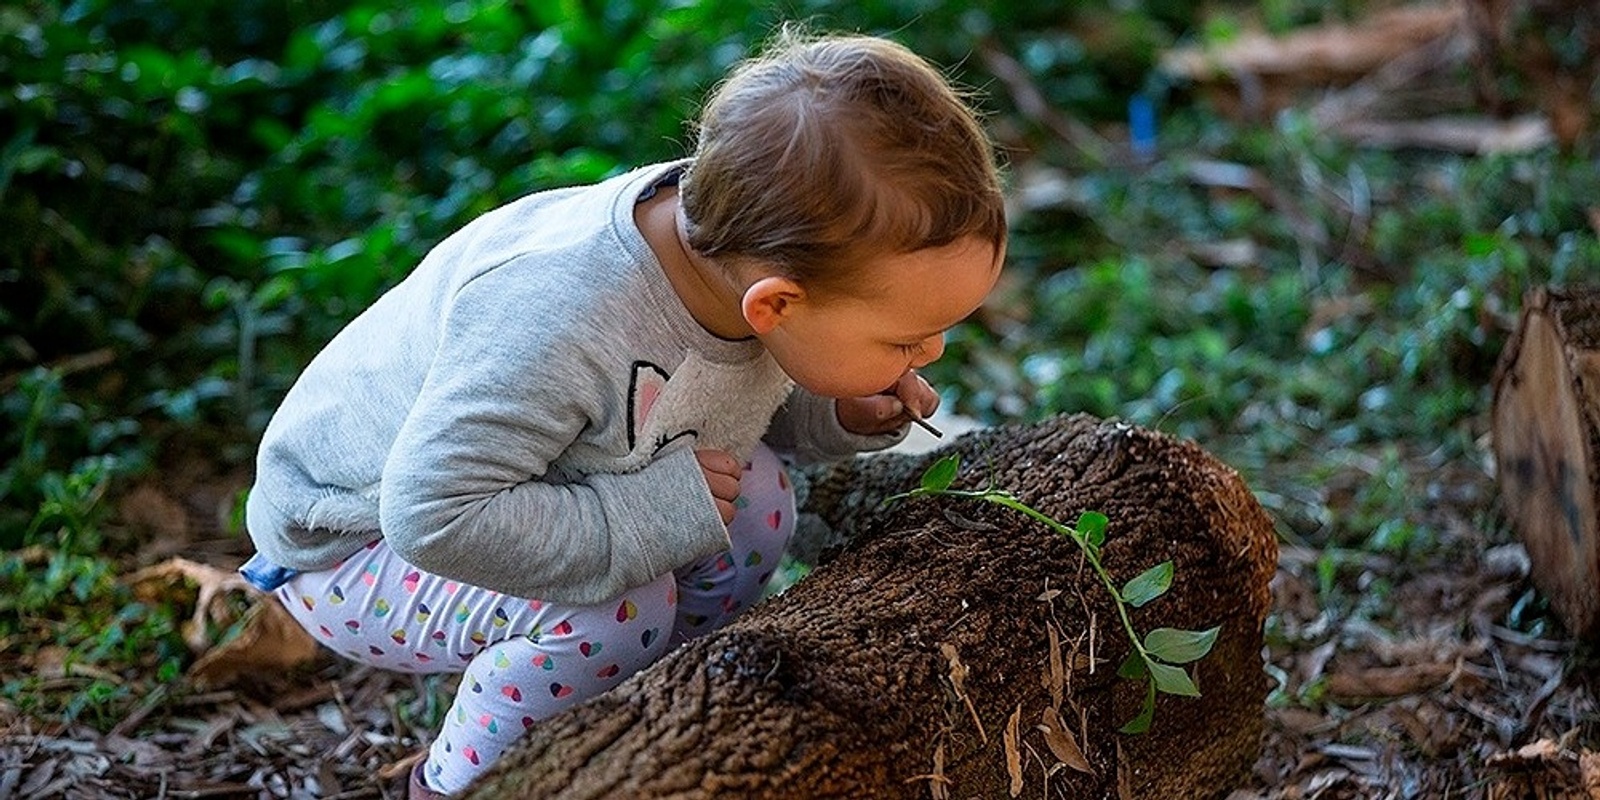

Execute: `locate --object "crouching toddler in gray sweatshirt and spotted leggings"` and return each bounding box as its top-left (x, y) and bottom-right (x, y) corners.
top-left (242, 30), bottom-right (1006, 797)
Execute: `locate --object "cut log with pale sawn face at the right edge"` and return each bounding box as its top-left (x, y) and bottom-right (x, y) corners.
top-left (1493, 288), bottom-right (1600, 640)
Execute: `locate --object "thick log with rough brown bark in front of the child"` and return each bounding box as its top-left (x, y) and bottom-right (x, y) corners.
top-left (469, 416), bottom-right (1277, 798)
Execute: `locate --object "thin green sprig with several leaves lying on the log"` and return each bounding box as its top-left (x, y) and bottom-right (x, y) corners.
top-left (890, 454), bottom-right (1219, 733)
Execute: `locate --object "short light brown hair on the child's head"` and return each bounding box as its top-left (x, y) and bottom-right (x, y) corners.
top-left (682, 27), bottom-right (1006, 299)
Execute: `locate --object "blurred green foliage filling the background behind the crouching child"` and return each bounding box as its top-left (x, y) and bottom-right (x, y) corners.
top-left (0, 0), bottom-right (1600, 720)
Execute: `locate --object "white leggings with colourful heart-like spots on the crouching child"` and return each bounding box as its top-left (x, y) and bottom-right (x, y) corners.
top-left (277, 446), bottom-right (795, 792)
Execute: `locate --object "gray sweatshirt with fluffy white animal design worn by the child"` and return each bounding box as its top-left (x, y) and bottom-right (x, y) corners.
top-left (246, 165), bottom-right (902, 603)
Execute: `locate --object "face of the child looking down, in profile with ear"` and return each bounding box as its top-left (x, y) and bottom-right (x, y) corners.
top-left (760, 237), bottom-right (1003, 397)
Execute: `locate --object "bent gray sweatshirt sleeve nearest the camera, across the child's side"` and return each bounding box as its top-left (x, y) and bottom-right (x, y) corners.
top-left (379, 262), bottom-right (730, 603)
